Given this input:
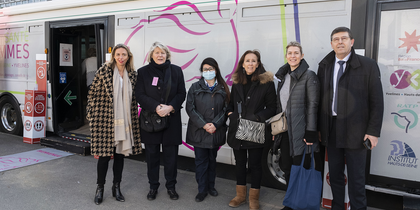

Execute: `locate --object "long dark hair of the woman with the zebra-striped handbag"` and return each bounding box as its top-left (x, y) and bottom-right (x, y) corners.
top-left (235, 50), bottom-right (265, 84)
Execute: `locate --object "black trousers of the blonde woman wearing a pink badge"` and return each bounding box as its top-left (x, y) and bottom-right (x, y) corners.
top-left (145, 144), bottom-right (179, 190)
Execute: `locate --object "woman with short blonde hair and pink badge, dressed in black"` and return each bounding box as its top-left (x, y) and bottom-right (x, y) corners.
top-left (136, 42), bottom-right (186, 200)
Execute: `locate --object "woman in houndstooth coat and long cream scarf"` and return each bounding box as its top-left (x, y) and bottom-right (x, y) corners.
top-left (87, 44), bottom-right (141, 205)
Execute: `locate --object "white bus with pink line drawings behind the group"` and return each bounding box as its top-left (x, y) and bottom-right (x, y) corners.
top-left (0, 0), bottom-right (420, 196)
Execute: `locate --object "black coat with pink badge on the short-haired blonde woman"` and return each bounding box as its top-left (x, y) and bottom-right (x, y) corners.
top-left (136, 61), bottom-right (186, 145)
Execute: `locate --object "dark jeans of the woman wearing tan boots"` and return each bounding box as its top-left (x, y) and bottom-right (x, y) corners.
top-left (233, 148), bottom-right (264, 189)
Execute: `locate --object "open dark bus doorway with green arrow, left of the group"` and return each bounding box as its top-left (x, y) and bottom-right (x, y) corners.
top-left (46, 16), bottom-right (114, 136)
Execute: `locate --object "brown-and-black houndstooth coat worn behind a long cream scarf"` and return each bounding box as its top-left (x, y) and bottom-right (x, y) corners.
top-left (87, 64), bottom-right (141, 157)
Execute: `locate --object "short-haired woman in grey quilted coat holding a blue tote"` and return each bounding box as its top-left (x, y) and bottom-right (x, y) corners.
top-left (273, 42), bottom-right (322, 210)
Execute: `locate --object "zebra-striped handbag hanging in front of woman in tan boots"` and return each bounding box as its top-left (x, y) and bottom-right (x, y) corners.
top-left (235, 102), bottom-right (265, 144)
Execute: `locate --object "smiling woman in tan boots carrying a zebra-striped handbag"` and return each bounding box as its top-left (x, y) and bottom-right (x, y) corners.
top-left (227, 50), bottom-right (276, 209)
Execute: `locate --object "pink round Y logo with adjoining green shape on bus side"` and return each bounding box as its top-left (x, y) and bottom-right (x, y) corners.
top-left (389, 69), bottom-right (420, 90)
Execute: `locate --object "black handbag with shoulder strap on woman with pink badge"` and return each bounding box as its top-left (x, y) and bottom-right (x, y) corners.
top-left (140, 67), bottom-right (171, 133)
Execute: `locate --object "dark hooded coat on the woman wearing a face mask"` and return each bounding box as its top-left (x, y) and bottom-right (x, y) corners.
top-left (186, 78), bottom-right (227, 149)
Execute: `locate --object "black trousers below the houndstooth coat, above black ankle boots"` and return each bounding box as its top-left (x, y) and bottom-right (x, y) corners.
top-left (96, 148), bottom-right (124, 185)
